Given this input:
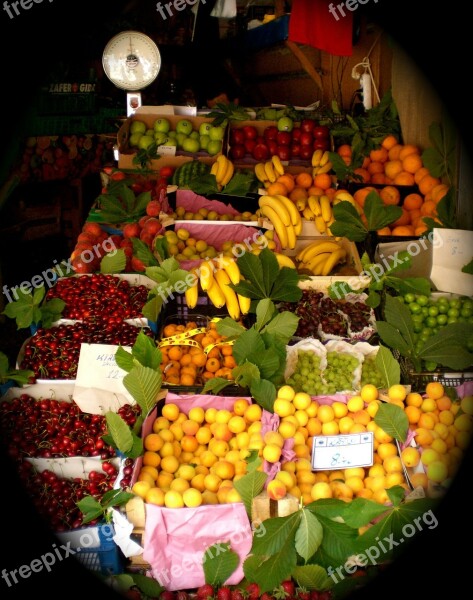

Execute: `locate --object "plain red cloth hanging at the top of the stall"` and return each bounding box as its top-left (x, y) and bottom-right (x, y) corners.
top-left (288, 0), bottom-right (352, 56)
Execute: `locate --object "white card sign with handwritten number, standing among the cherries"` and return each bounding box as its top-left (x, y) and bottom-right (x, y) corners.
top-left (72, 344), bottom-right (135, 415)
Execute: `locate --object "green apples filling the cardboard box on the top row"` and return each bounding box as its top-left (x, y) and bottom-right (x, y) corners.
top-left (128, 117), bottom-right (225, 156)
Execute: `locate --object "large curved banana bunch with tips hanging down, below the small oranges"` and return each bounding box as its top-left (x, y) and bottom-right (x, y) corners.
top-left (258, 194), bottom-right (302, 250)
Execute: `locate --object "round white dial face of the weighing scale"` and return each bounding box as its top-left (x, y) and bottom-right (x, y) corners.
top-left (102, 31), bottom-right (161, 92)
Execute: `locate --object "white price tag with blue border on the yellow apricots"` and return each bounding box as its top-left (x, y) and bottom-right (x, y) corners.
top-left (312, 431), bottom-right (374, 471)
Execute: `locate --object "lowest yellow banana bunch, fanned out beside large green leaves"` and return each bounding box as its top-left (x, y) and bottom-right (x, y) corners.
top-left (185, 254), bottom-right (251, 320)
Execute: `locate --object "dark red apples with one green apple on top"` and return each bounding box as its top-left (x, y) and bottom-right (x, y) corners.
top-left (230, 116), bottom-right (330, 162)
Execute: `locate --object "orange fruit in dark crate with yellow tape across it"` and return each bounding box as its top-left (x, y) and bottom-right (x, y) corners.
top-left (160, 321), bottom-right (236, 386)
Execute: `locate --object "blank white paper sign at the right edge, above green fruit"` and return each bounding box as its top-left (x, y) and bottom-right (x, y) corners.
top-left (430, 229), bottom-right (473, 296)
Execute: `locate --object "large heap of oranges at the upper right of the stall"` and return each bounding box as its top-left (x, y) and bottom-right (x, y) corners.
top-left (337, 135), bottom-right (449, 236)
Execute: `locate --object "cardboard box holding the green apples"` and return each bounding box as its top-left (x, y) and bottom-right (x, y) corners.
top-left (117, 107), bottom-right (226, 171)
